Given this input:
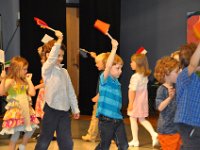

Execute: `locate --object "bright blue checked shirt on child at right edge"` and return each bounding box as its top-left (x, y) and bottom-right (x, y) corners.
top-left (174, 68), bottom-right (200, 127)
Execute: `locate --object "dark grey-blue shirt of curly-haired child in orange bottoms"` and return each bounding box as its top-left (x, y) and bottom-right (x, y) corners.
top-left (156, 85), bottom-right (177, 134)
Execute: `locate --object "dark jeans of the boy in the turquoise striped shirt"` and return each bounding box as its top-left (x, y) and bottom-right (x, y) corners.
top-left (95, 115), bottom-right (128, 150)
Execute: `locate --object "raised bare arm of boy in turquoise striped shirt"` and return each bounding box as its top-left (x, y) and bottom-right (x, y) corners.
top-left (104, 39), bottom-right (118, 79)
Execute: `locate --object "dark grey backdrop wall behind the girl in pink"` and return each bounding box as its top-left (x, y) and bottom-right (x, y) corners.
top-left (120, 0), bottom-right (200, 106)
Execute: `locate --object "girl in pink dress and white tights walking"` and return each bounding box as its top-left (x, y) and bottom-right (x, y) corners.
top-left (128, 54), bottom-right (158, 146)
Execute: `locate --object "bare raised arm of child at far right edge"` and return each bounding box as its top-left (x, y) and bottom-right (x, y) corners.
top-left (188, 43), bottom-right (200, 76)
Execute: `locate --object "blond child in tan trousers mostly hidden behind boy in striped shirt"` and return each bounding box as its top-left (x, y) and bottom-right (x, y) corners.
top-left (82, 52), bottom-right (106, 141)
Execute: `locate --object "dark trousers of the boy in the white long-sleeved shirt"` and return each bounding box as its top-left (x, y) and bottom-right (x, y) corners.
top-left (35, 104), bottom-right (73, 150)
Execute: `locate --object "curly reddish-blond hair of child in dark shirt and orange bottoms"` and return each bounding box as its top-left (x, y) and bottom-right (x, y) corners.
top-left (154, 56), bottom-right (180, 83)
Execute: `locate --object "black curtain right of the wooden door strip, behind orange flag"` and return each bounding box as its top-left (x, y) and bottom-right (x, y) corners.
top-left (79, 0), bottom-right (121, 114)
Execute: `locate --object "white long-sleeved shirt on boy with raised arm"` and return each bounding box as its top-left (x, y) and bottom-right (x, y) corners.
top-left (42, 43), bottom-right (80, 113)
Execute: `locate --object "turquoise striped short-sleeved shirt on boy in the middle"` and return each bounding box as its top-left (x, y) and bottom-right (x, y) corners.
top-left (97, 73), bottom-right (123, 119)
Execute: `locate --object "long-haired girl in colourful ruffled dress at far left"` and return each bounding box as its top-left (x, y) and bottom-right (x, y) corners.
top-left (0, 56), bottom-right (39, 150)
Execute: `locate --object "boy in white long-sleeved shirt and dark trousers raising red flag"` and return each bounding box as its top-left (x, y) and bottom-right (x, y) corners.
top-left (35, 30), bottom-right (80, 150)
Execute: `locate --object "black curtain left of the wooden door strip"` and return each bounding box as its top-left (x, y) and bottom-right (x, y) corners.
top-left (20, 0), bottom-right (66, 105)
